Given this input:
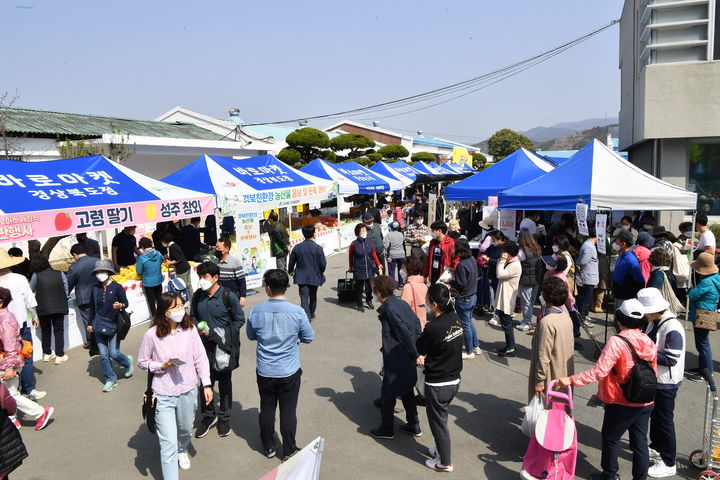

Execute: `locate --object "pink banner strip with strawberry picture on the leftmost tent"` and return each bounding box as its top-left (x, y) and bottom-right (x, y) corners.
top-left (0, 196), bottom-right (215, 242)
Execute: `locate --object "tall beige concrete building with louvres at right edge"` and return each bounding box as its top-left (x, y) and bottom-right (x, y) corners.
top-left (619, 0), bottom-right (720, 221)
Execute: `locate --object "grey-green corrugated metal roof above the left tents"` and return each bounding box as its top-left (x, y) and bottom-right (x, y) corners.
top-left (0, 108), bottom-right (229, 140)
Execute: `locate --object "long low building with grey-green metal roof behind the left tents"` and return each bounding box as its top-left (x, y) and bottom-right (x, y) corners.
top-left (0, 108), bottom-right (269, 178)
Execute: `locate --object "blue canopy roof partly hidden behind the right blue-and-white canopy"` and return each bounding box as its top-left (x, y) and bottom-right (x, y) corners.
top-left (445, 148), bottom-right (554, 202)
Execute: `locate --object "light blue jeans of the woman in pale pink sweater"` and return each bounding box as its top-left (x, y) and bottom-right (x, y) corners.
top-left (155, 388), bottom-right (198, 480)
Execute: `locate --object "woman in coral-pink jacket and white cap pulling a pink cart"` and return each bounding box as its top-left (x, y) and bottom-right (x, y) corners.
top-left (558, 298), bottom-right (657, 480)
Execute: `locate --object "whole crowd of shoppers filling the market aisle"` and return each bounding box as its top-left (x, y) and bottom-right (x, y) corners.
top-left (0, 202), bottom-right (720, 480)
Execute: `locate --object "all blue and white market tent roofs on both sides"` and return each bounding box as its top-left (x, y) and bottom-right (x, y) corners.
top-left (0, 140), bottom-right (697, 242)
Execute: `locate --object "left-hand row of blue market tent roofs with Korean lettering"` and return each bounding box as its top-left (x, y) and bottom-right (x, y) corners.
top-left (0, 155), bottom-right (473, 243)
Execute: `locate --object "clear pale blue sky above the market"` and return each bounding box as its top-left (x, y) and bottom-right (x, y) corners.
top-left (0, 0), bottom-right (622, 142)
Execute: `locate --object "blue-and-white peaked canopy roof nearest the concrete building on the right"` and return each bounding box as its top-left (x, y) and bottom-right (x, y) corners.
top-left (498, 140), bottom-right (697, 210)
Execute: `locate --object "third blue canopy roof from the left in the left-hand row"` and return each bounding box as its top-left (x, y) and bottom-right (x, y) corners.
top-left (300, 158), bottom-right (402, 195)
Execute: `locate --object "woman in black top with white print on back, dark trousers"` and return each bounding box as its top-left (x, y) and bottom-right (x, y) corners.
top-left (416, 283), bottom-right (463, 472)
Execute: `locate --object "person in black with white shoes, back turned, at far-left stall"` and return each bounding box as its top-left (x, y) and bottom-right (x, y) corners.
top-left (30, 256), bottom-right (68, 365)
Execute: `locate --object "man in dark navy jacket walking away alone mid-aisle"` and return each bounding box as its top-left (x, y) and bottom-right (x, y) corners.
top-left (288, 225), bottom-right (327, 321)
